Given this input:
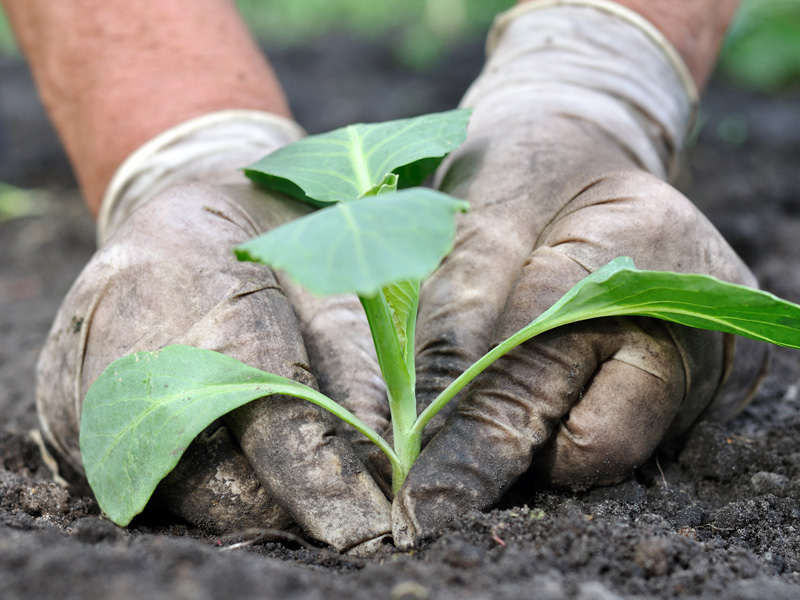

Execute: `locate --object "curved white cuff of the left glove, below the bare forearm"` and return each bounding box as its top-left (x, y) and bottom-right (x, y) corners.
top-left (97, 110), bottom-right (305, 246)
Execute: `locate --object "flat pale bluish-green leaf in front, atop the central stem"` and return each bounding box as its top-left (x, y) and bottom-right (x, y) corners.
top-left (234, 188), bottom-right (469, 296)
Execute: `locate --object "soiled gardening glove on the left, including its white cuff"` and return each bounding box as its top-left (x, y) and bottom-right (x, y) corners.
top-left (37, 111), bottom-right (390, 553)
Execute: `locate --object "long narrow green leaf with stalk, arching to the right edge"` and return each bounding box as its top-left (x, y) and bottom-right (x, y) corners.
top-left (414, 257), bottom-right (800, 431)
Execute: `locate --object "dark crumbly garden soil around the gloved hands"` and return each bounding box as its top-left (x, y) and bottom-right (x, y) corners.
top-left (0, 37), bottom-right (800, 600)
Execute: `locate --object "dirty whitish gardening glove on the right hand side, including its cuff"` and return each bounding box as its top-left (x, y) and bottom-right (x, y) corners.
top-left (392, 1), bottom-right (764, 547)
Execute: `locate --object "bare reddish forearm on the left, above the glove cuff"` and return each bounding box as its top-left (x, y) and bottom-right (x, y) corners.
top-left (2, 0), bottom-right (289, 213)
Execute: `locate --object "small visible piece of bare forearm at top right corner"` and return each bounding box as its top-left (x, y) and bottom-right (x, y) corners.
top-left (520, 0), bottom-right (739, 89)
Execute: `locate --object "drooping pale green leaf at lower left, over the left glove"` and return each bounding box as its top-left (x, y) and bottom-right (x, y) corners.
top-left (80, 346), bottom-right (392, 526)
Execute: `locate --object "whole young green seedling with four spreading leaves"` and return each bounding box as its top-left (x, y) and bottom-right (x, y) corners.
top-left (80, 111), bottom-right (800, 525)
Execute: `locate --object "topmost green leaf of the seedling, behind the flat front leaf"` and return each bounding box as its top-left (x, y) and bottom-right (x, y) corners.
top-left (244, 109), bottom-right (470, 206)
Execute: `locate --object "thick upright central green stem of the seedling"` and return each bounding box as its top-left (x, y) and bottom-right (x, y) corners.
top-left (359, 291), bottom-right (422, 492)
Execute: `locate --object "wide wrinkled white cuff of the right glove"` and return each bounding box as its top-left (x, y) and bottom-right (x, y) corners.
top-left (462, 0), bottom-right (699, 179)
